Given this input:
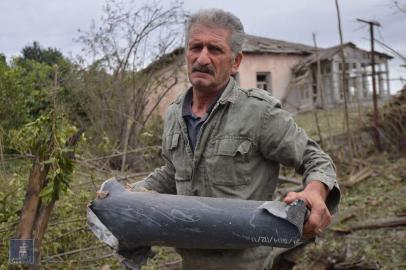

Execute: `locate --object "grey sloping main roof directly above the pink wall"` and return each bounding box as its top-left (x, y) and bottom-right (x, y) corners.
top-left (243, 34), bottom-right (315, 55)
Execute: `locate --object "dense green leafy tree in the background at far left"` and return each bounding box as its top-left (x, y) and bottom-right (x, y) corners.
top-left (0, 42), bottom-right (77, 134)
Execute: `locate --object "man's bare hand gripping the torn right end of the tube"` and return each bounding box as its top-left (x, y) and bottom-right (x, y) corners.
top-left (283, 181), bottom-right (331, 238)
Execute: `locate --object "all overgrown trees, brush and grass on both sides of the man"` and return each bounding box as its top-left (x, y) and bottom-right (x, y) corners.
top-left (0, 1), bottom-right (406, 270)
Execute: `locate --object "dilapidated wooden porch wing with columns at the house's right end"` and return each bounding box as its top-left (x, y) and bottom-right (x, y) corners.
top-left (283, 43), bottom-right (392, 111)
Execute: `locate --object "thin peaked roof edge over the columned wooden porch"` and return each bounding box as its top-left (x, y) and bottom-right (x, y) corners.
top-left (293, 42), bottom-right (393, 71)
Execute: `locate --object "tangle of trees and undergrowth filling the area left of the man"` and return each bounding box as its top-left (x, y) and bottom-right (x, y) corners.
top-left (0, 1), bottom-right (184, 269)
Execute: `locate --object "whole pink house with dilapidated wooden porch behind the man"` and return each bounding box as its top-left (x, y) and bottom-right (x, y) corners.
top-left (147, 35), bottom-right (392, 115)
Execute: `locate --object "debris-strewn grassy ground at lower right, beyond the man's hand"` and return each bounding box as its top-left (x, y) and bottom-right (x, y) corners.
top-left (294, 154), bottom-right (406, 270)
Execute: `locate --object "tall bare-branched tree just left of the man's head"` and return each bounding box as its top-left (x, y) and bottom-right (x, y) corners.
top-left (78, 1), bottom-right (184, 170)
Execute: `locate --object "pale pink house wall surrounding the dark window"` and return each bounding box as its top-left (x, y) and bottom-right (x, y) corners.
top-left (238, 54), bottom-right (304, 100)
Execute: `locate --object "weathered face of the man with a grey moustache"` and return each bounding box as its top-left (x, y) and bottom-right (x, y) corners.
top-left (186, 24), bottom-right (242, 92)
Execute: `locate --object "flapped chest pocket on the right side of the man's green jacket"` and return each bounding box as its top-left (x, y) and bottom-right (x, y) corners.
top-left (208, 138), bottom-right (252, 186)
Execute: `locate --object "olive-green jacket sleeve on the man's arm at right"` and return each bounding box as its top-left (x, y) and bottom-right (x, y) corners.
top-left (259, 104), bottom-right (341, 213)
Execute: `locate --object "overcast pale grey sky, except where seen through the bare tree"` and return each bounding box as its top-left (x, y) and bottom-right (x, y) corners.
top-left (0, 0), bottom-right (406, 93)
